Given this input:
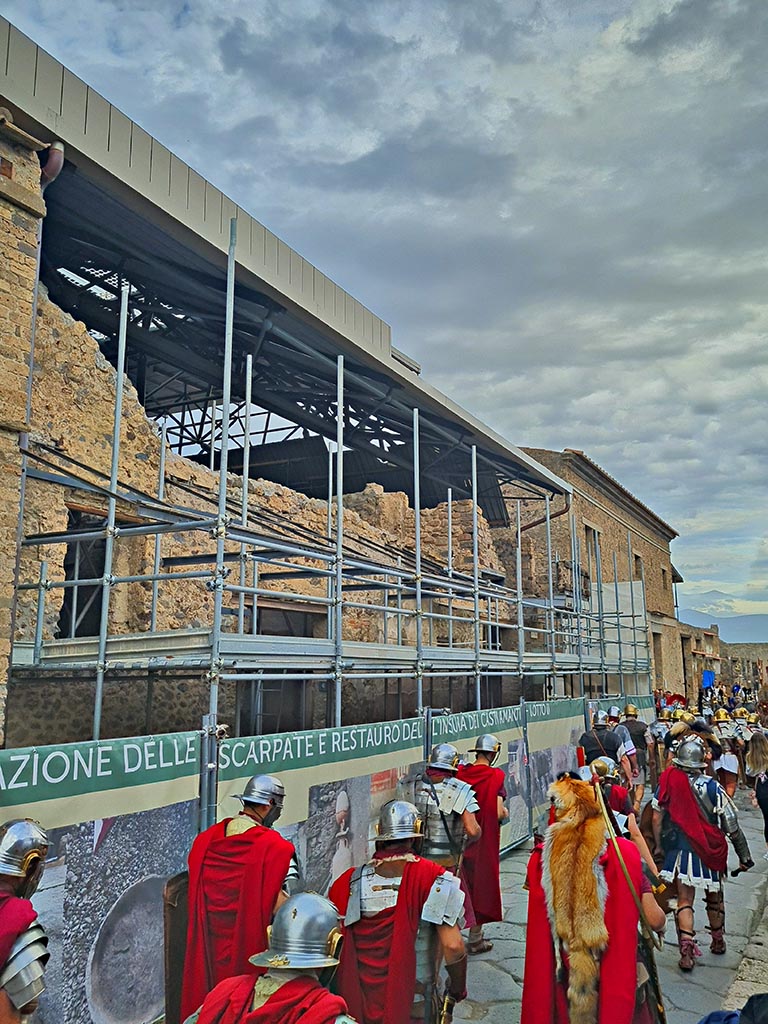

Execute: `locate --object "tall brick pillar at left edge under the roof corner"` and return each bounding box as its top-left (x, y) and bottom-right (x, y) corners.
top-left (0, 110), bottom-right (45, 745)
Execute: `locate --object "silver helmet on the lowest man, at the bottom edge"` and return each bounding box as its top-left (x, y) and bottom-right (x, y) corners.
top-left (251, 893), bottom-right (341, 971)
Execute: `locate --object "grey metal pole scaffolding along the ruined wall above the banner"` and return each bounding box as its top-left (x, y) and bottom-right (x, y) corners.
top-left (13, 220), bottom-right (649, 745)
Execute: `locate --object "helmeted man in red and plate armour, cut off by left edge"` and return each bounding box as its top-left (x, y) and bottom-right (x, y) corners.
top-left (0, 818), bottom-right (48, 1024)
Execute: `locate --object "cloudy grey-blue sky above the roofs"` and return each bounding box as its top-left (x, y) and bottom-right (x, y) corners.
top-left (0, 0), bottom-right (768, 612)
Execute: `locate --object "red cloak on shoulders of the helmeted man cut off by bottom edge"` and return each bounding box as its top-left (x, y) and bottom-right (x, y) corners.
top-left (199, 974), bottom-right (347, 1024)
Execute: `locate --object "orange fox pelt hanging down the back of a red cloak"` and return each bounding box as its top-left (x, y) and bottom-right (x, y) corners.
top-left (542, 777), bottom-right (608, 1024)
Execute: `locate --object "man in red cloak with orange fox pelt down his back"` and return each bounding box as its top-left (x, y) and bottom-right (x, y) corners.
top-left (520, 776), bottom-right (665, 1024)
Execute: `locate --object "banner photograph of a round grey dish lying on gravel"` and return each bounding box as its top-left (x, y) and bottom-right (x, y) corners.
top-left (32, 800), bottom-right (198, 1024)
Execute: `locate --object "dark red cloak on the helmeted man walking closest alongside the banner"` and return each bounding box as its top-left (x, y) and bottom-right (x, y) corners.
top-left (458, 761), bottom-right (506, 925)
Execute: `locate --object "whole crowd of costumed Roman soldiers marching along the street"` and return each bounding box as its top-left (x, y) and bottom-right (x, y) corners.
top-left (0, 705), bottom-right (768, 1024)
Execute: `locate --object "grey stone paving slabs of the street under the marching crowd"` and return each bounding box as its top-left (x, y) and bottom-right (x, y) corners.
top-left (454, 792), bottom-right (768, 1024)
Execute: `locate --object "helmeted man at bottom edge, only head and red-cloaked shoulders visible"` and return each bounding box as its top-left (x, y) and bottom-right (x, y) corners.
top-left (184, 893), bottom-right (354, 1024)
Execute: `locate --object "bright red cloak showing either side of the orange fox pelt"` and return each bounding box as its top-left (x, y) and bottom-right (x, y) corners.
top-left (520, 839), bottom-right (642, 1024)
